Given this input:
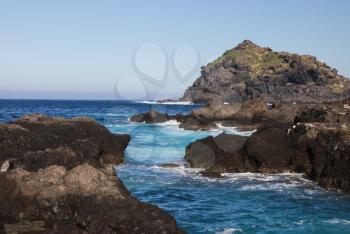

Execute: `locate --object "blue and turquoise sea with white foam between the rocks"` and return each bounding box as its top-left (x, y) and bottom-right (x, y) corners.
top-left (0, 100), bottom-right (350, 233)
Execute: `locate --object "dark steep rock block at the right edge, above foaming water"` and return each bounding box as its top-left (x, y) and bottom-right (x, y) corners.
top-left (289, 124), bottom-right (350, 191)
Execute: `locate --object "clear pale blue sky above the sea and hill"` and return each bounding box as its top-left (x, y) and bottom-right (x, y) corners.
top-left (0, 0), bottom-right (350, 99)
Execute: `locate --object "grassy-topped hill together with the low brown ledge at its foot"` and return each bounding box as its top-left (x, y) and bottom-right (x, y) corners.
top-left (131, 40), bottom-right (350, 130)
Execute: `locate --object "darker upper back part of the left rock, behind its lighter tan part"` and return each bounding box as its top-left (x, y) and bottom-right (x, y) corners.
top-left (0, 115), bottom-right (130, 168)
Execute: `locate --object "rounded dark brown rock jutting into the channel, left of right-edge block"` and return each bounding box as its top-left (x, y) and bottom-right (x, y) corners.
top-left (185, 127), bottom-right (291, 176)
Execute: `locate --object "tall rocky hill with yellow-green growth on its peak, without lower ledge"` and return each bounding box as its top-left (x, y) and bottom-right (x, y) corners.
top-left (180, 40), bottom-right (350, 103)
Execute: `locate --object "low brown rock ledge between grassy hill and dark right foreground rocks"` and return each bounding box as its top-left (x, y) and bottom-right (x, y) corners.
top-left (131, 98), bottom-right (350, 133)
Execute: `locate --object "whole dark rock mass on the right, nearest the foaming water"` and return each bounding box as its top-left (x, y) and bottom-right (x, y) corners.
top-left (185, 119), bottom-right (350, 191)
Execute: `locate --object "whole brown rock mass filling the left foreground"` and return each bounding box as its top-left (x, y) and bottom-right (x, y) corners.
top-left (0, 115), bottom-right (181, 233)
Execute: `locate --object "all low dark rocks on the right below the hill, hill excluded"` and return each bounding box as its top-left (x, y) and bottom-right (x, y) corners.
top-left (131, 99), bottom-right (350, 191)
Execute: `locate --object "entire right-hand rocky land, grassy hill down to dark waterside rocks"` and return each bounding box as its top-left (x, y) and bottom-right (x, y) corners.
top-left (131, 40), bottom-right (350, 191)
